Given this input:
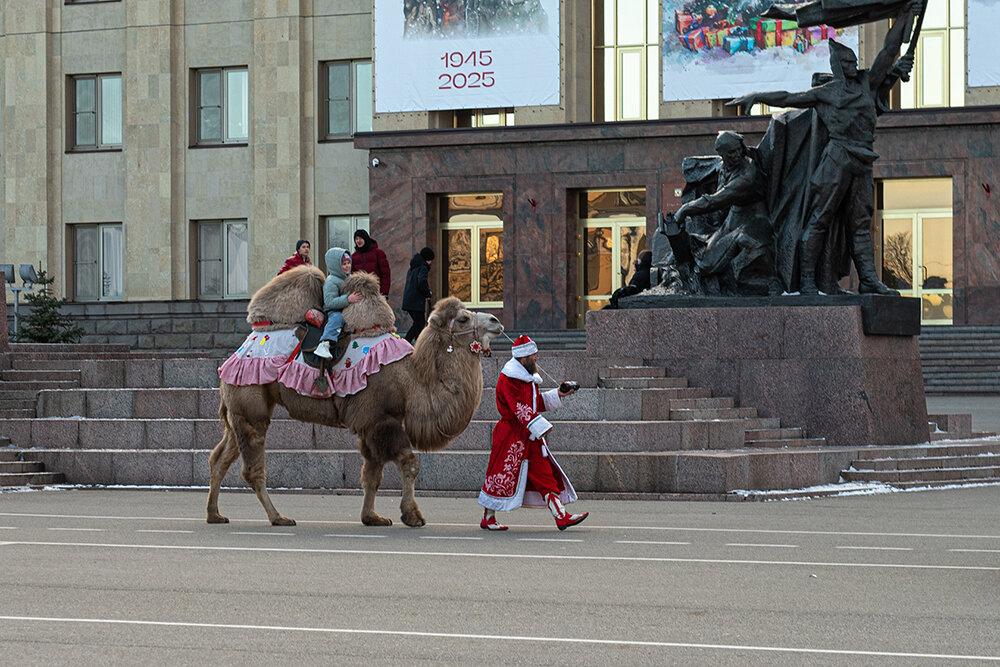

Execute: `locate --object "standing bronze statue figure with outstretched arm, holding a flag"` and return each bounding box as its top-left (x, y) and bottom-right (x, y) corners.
top-left (654, 0), bottom-right (925, 295)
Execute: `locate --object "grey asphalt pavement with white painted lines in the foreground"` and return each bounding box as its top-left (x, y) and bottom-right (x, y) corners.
top-left (0, 486), bottom-right (1000, 666)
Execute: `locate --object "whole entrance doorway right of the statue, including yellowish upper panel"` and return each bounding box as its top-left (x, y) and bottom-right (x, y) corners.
top-left (880, 178), bottom-right (954, 325)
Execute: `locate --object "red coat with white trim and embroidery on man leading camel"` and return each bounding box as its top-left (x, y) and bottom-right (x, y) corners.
top-left (479, 359), bottom-right (577, 511)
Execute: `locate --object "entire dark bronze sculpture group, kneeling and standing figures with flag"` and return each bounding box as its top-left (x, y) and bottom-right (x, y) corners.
top-left (653, 0), bottom-right (924, 296)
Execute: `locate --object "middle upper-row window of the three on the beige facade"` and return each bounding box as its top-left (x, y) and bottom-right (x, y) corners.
top-left (193, 67), bottom-right (250, 145)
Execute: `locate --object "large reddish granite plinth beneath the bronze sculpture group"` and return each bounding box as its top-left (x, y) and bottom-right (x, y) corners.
top-left (587, 296), bottom-right (928, 446)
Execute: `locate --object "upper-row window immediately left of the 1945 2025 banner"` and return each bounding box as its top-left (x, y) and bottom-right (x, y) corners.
top-left (319, 60), bottom-right (372, 139)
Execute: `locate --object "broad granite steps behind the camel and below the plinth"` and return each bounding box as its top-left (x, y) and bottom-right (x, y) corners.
top-left (0, 346), bottom-right (992, 498)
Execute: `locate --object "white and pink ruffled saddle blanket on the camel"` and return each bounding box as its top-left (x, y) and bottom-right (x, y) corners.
top-left (219, 329), bottom-right (413, 398)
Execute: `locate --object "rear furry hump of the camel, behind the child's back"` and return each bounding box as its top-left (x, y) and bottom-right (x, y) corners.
top-left (247, 264), bottom-right (326, 331)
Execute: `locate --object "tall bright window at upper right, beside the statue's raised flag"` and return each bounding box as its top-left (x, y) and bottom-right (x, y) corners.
top-left (898, 0), bottom-right (965, 109)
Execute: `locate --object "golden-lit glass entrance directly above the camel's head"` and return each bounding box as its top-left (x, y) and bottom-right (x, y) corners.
top-left (439, 193), bottom-right (503, 308)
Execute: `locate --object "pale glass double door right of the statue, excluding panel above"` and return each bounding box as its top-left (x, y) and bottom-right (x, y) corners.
top-left (882, 209), bottom-right (954, 324)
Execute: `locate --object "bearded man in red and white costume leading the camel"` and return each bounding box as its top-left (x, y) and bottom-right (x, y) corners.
top-left (479, 335), bottom-right (588, 530)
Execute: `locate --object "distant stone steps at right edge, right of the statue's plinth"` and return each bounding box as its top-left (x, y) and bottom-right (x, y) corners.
top-left (918, 326), bottom-right (1000, 395)
